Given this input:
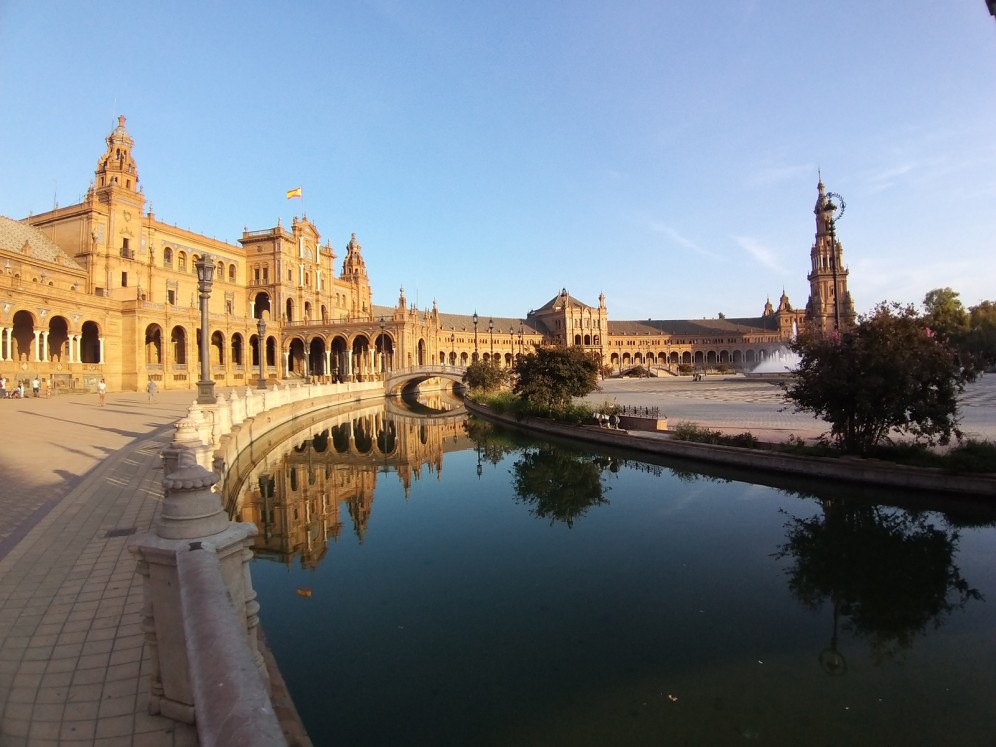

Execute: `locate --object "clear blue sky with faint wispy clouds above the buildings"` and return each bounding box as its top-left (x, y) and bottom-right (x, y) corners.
top-left (0, 0), bottom-right (996, 320)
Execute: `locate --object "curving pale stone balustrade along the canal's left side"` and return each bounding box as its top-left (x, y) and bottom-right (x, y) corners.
top-left (135, 382), bottom-right (384, 747)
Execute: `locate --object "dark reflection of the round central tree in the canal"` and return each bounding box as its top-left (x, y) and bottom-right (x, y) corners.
top-left (512, 447), bottom-right (614, 527)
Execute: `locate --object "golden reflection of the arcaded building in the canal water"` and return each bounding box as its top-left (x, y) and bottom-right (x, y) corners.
top-left (234, 406), bottom-right (469, 568)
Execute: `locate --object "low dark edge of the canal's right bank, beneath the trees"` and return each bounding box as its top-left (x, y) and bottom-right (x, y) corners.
top-left (464, 398), bottom-right (996, 498)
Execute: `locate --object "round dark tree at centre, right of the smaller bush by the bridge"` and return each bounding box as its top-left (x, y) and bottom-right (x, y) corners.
top-left (513, 345), bottom-right (599, 410)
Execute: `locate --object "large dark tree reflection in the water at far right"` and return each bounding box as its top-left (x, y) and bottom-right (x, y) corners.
top-left (777, 501), bottom-right (981, 661)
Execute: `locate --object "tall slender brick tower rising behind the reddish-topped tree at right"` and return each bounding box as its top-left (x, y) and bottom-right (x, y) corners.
top-left (806, 179), bottom-right (854, 333)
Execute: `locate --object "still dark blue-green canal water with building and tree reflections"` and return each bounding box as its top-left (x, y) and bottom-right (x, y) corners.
top-left (233, 402), bottom-right (996, 747)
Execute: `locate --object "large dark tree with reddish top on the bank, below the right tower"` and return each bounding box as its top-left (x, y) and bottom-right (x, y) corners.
top-left (785, 304), bottom-right (968, 454)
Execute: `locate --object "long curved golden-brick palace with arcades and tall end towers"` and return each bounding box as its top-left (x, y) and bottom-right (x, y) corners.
top-left (0, 117), bottom-right (853, 390)
